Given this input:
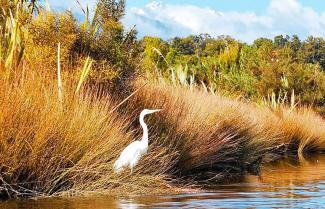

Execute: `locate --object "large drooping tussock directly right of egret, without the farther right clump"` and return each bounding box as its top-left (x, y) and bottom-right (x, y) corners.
top-left (125, 83), bottom-right (278, 180)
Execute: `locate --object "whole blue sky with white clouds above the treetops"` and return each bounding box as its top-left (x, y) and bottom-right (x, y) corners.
top-left (49, 0), bottom-right (325, 42)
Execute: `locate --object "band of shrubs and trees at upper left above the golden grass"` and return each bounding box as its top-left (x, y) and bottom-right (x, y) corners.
top-left (0, 0), bottom-right (139, 84)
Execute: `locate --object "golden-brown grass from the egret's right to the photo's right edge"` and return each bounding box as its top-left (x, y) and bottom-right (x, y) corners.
top-left (128, 79), bottom-right (325, 180)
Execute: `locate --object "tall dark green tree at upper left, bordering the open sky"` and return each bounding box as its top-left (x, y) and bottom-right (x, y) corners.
top-left (75, 0), bottom-right (138, 83)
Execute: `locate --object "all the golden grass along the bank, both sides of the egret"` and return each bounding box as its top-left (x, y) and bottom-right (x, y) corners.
top-left (0, 67), bottom-right (325, 197)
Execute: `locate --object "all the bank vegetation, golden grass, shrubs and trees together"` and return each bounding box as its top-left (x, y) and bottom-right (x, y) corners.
top-left (0, 0), bottom-right (325, 198)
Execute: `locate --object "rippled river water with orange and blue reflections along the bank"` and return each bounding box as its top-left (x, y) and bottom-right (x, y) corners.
top-left (0, 156), bottom-right (325, 209)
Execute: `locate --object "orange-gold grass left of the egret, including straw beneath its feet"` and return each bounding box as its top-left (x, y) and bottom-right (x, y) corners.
top-left (0, 72), bottom-right (178, 197)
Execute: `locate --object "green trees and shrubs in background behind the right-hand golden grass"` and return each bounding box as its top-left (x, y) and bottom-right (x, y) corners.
top-left (142, 35), bottom-right (325, 108)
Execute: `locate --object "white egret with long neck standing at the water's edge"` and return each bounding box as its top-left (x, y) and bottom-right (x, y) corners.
top-left (113, 109), bottom-right (160, 173)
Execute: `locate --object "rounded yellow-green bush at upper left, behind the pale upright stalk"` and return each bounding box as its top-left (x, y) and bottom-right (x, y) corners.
top-left (26, 11), bottom-right (77, 67)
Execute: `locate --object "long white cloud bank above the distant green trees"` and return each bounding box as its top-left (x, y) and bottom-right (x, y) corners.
top-left (123, 0), bottom-right (325, 42)
